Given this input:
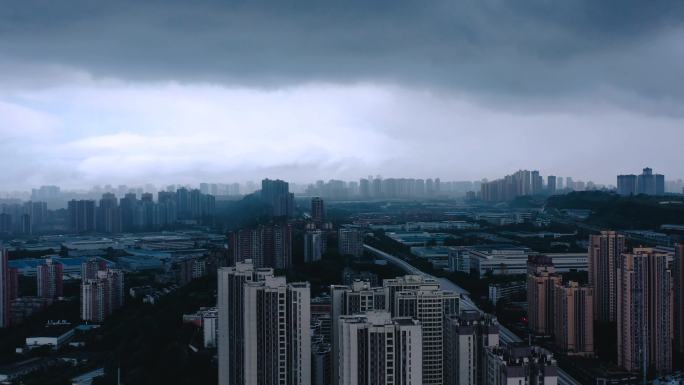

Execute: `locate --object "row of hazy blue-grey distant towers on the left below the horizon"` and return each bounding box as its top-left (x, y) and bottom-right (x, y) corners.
top-left (67, 187), bottom-right (216, 233)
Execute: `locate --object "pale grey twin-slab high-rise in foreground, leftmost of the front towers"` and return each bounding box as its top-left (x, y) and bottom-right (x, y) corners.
top-left (218, 260), bottom-right (311, 385)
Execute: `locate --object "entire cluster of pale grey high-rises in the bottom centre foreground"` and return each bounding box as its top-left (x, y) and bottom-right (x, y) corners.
top-left (216, 260), bottom-right (557, 385)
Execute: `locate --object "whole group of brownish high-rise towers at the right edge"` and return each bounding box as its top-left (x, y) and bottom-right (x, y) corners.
top-left (527, 231), bottom-right (684, 375)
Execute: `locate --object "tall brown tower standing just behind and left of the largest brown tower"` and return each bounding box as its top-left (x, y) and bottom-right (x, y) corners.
top-left (587, 231), bottom-right (625, 322)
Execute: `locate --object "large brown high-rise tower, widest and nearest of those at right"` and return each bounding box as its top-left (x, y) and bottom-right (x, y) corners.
top-left (617, 248), bottom-right (673, 374)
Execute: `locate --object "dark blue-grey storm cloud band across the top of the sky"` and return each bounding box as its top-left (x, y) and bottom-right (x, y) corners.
top-left (0, 0), bottom-right (684, 100)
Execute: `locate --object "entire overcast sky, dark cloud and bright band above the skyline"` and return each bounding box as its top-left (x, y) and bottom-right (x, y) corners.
top-left (0, 0), bottom-right (684, 190)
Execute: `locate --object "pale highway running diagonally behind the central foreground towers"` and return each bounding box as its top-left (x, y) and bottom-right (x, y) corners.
top-left (363, 244), bottom-right (580, 385)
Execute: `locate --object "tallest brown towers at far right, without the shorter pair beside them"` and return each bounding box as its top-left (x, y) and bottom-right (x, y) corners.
top-left (589, 231), bottom-right (684, 374)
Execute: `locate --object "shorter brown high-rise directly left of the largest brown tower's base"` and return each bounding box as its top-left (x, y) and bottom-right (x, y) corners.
top-left (553, 281), bottom-right (594, 356)
